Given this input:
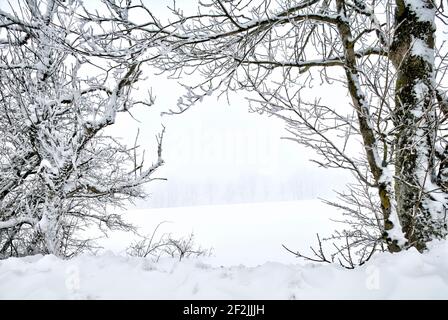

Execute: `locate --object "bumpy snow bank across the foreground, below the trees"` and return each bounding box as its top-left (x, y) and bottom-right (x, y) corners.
top-left (0, 242), bottom-right (448, 299)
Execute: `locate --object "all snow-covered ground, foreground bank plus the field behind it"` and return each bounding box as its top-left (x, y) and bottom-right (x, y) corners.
top-left (0, 201), bottom-right (448, 299)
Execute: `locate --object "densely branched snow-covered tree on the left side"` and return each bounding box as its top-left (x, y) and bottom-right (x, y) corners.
top-left (0, 0), bottom-right (163, 258)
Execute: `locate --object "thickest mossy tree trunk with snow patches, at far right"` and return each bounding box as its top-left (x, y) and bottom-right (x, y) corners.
top-left (390, 0), bottom-right (446, 251)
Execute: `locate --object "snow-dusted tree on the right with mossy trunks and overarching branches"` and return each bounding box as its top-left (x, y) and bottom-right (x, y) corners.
top-left (109, 0), bottom-right (448, 252)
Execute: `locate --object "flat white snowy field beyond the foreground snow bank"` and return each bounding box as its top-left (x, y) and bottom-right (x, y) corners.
top-left (99, 200), bottom-right (340, 266)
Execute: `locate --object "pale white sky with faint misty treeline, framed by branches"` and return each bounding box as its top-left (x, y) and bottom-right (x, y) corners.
top-left (0, 0), bottom-right (356, 208)
